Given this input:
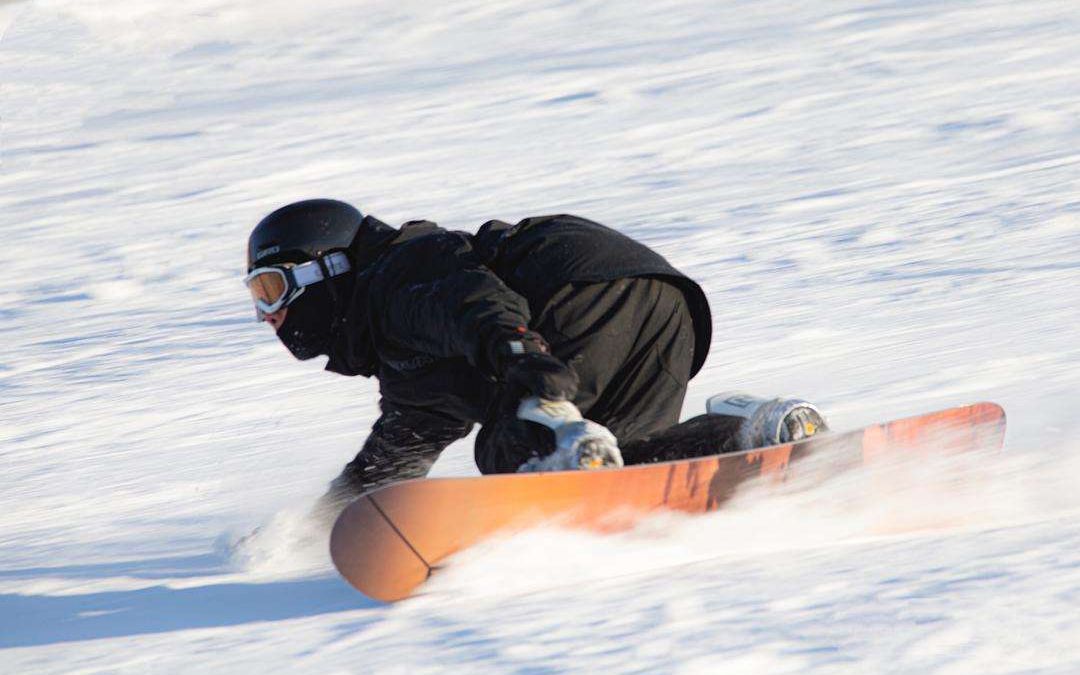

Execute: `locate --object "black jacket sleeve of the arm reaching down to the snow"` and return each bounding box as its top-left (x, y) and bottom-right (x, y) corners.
top-left (330, 402), bottom-right (472, 501)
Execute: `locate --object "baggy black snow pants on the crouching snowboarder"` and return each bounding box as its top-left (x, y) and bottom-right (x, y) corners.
top-left (475, 278), bottom-right (730, 473)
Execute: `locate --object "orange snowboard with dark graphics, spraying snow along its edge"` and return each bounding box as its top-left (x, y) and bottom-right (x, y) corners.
top-left (330, 403), bottom-right (1005, 602)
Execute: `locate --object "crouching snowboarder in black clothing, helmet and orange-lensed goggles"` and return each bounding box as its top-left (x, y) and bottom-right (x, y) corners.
top-left (245, 199), bottom-right (824, 504)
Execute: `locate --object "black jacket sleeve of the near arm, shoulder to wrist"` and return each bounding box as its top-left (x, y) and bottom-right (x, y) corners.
top-left (380, 232), bottom-right (530, 375)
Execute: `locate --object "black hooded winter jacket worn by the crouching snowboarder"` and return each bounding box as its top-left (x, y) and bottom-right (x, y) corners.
top-left (327, 215), bottom-right (712, 489)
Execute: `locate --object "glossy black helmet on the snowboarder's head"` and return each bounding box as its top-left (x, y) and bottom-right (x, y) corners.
top-left (247, 199), bottom-right (364, 272)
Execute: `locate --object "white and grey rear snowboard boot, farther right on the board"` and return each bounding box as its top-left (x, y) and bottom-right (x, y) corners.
top-left (707, 392), bottom-right (828, 450)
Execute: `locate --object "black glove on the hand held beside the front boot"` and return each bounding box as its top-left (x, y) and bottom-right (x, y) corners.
top-left (497, 330), bottom-right (579, 401)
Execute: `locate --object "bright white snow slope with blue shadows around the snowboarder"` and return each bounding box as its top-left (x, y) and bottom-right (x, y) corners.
top-left (0, 0), bottom-right (1080, 673)
